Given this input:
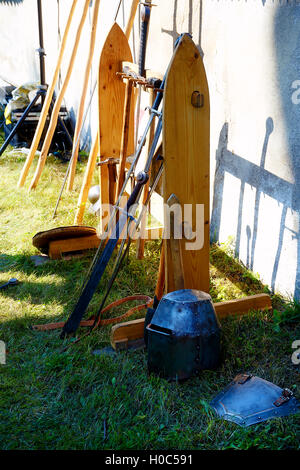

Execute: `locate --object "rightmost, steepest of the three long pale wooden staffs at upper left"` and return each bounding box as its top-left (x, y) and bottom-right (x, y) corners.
top-left (67, 0), bottom-right (100, 191)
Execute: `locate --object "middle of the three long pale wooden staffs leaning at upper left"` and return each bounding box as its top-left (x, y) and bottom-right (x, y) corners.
top-left (29, 0), bottom-right (90, 190)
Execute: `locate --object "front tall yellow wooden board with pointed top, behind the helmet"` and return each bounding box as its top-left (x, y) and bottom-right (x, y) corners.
top-left (163, 34), bottom-right (210, 292)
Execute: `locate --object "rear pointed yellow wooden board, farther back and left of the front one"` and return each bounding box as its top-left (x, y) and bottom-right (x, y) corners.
top-left (98, 23), bottom-right (134, 225)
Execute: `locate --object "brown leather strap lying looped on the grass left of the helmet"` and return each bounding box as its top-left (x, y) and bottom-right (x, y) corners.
top-left (32, 295), bottom-right (153, 331)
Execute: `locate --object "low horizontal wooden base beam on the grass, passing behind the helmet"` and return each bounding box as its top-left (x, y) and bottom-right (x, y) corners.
top-left (111, 294), bottom-right (272, 349)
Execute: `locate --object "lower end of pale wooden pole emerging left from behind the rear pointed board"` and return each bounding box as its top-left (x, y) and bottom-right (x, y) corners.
top-left (74, 138), bottom-right (99, 225)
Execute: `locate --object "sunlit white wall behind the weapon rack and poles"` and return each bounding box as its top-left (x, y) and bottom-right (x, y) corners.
top-left (0, 0), bottom-right (300, 297)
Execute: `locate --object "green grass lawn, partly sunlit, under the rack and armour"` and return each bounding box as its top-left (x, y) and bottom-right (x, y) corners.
top-left (0, 142), bottom-right (300, 450)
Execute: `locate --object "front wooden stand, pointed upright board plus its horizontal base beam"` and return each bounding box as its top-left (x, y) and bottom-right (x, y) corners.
top-left (111, 35), bottom-right (272, 350)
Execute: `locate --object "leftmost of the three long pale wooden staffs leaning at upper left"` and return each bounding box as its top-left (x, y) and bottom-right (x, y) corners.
top-left (18, 0), bottom-right (78, 188)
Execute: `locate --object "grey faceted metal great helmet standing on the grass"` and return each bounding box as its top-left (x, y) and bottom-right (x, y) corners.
top-left (147, 289), bottom-right (221, 380)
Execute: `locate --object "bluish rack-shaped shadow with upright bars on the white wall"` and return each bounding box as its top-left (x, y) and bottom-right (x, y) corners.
top-left (211, 117), bottom-right (296, 296)
